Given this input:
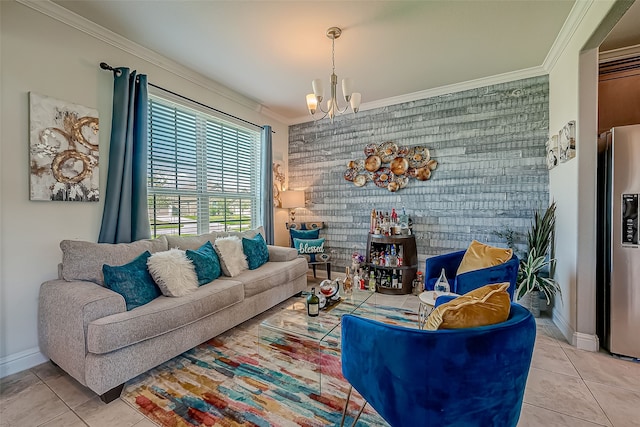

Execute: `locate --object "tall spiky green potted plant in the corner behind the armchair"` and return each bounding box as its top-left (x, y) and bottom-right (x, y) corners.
top-left (516, 202), bottom-right (562, 317)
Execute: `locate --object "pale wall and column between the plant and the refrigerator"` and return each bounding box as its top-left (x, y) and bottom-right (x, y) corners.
top-left (549, 0), bottom-right (614, 350)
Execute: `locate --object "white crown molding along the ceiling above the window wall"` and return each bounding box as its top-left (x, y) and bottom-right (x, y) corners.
top-left (16, 0), bottom-right (274, 117)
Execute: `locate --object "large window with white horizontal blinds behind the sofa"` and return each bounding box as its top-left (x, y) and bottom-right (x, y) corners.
top-left (147, 95), bottom-right (260, 237)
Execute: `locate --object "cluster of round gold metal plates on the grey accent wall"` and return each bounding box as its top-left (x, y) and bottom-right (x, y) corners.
top-left (343, 141), bottom-right (438, 192)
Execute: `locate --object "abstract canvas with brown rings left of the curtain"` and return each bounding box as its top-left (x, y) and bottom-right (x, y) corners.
top-left (29, 92), bottom-right (100, 202)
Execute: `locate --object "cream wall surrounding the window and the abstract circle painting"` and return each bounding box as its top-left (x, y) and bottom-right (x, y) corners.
top-left (0, 1), bottom-right (288, 376)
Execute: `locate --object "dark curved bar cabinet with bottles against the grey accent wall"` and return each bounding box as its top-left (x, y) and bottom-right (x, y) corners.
top-left (366, 233), bottom-right (418, 295)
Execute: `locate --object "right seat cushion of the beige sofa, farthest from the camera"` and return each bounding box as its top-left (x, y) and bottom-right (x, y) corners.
top-left (218, 258), bottom-right (309, 298)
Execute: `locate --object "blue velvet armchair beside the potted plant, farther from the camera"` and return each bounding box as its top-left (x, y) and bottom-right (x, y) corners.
top-left (424, 251), bottom-right (520, 301)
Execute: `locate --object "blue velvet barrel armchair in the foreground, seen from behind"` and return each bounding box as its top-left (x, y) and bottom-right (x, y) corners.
top-left (341, 303), bottom-right (536, 427)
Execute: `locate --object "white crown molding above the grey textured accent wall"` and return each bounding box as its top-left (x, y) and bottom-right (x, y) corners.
top-left (288, 66), bottom-right (548, 125)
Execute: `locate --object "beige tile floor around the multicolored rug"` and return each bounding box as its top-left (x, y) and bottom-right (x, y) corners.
top-left (0, 277), bottom-right (640, 427)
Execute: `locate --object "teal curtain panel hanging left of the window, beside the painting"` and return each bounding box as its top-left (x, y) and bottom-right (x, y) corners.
top-left (98, 67), bottom-right (151, 243)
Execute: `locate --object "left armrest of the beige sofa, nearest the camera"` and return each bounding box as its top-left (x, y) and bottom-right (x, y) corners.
top-left (38, 280), bottom-right (127, 384)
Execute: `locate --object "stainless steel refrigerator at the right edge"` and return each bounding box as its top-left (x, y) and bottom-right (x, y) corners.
top-left (597, 125), bottom-right (640, 358)
